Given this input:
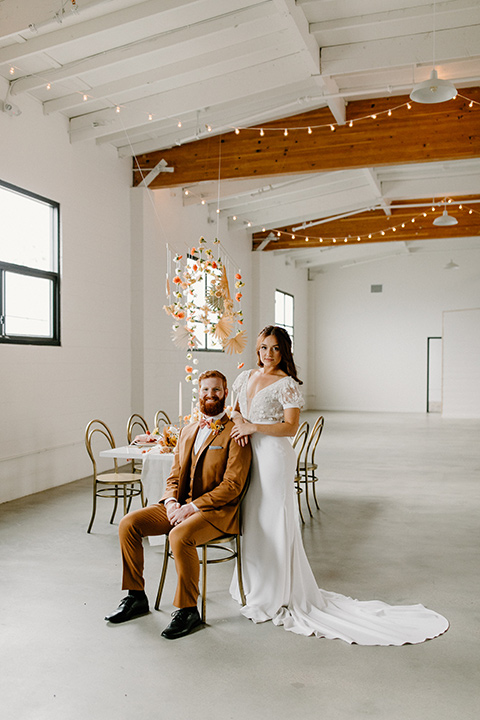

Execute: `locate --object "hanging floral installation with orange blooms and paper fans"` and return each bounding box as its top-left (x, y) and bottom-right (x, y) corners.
top-left (163, 237), bottom-right (247, 411)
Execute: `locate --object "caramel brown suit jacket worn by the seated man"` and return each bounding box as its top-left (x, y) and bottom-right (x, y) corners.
top-left (160, 415), bottom-right (252, 533)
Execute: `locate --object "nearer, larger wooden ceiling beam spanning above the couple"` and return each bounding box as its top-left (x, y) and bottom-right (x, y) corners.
top-left (133, 87), bottom-right (480, 189)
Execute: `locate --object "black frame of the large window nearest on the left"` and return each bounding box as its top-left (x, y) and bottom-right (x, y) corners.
top-left (0, 180), bottom-right (61, 346)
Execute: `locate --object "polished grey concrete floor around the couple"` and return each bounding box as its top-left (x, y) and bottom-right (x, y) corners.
top-left (0, 413), bottom-right (480, 720)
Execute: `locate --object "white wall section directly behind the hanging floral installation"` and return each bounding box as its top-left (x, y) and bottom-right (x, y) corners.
top-left (127, 188), bottom-right (255, 424)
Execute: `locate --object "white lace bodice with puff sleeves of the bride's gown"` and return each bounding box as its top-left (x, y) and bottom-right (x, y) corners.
top-left (233, 370), bottom-right (303, 423)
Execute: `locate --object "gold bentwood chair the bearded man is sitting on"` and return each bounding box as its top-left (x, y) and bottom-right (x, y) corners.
top-left (155, 474), bottom-right (250, 622)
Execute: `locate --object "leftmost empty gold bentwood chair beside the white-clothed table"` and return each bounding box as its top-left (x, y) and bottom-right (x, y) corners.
top-left (85, 420), bottom-right (145, 533)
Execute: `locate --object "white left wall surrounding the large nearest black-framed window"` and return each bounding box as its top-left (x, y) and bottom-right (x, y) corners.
top-left (0, 88), bottom-right (131, 502)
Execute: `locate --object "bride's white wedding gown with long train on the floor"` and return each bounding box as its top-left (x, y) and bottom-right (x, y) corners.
top-left (230, 371), bottom-right (448, 645)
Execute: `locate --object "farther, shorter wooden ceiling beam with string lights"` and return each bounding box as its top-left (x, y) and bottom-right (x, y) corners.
top-left (252, 195), bottom-right (480, 252)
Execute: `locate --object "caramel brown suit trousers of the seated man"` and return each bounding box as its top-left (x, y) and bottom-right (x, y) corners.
top-left (119, 503), bottom-right (222, 608)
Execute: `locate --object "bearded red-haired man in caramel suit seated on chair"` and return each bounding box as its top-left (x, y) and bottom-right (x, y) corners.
top-left (105, 370), bottom-right (251, 640)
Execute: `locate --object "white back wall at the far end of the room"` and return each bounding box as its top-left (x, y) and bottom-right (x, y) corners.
top-left (310, 245), bottom-right (480, 412)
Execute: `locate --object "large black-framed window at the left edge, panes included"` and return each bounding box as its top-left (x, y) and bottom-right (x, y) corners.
top-left (0, 181), bottom-right (60, 345)
